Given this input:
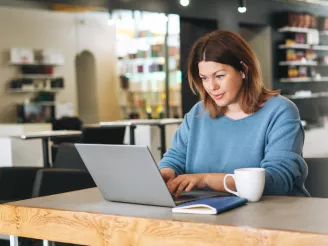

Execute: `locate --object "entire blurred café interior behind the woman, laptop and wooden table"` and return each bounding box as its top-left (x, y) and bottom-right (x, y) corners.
top-left (0, 0), bottom-right (328, 245)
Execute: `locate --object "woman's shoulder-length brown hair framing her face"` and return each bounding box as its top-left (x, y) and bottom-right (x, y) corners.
top-left (188, 30), bottom-right (280, 118)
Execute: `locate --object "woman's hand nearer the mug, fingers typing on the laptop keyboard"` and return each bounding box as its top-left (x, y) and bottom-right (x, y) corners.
top-left (167, 173), bottom-right (207, 197)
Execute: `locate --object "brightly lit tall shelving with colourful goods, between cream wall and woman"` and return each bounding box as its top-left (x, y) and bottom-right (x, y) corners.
top-left (112, 10), bottom-right (182, 119)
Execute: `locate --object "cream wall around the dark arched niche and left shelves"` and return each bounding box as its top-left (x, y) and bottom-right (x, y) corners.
top-left (0, 7), bottom-right (119, 122)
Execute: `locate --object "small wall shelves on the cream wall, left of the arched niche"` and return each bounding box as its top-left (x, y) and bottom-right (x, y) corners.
top-left (6, 48), bottom-right (64, 123)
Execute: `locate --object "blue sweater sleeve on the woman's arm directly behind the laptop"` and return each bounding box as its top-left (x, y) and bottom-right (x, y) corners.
top-left (158, 113), bottom-right (190, 175)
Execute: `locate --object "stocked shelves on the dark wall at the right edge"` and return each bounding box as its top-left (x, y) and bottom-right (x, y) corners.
top-left (275, 11), bottom-right (328, 124)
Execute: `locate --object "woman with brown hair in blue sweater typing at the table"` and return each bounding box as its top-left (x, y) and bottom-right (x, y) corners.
top-left (159, 30), bottom-right (309, 196)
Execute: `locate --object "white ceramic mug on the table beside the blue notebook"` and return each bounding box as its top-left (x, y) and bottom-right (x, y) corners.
top-left (223, 168), bottom-right (265, 202)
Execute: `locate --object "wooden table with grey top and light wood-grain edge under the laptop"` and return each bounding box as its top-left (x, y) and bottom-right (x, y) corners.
top-left (0, 188), bottom-right (328, 246)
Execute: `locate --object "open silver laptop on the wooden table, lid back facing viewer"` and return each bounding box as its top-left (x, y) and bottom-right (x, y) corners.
top-left (74, 144), bottom-right (226, 207)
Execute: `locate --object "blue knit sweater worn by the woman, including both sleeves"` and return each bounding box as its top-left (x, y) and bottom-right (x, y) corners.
top-left (159, 95), bottom-right (309, 196)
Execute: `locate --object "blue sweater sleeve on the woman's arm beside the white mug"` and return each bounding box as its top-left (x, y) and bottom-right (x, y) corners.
top-left (261, 117), bottom-right (308, 195)
